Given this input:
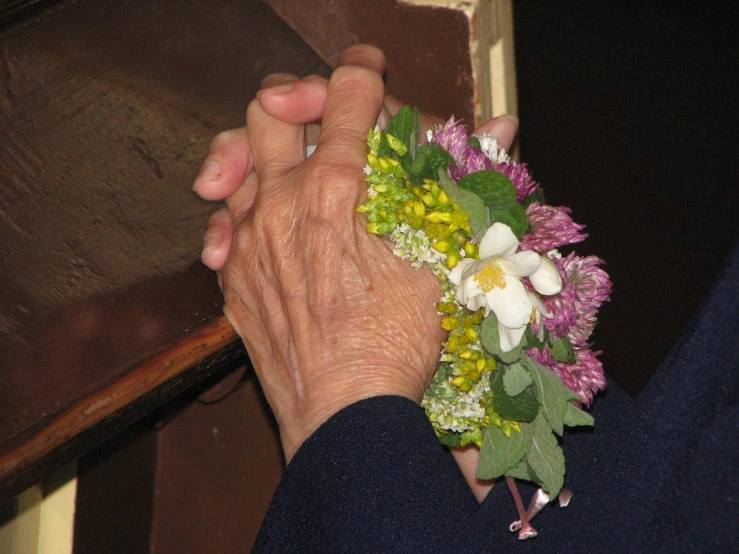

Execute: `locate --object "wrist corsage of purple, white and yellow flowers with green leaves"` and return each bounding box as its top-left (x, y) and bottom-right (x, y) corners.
top-left (358, 106), bottom-right (611, 539)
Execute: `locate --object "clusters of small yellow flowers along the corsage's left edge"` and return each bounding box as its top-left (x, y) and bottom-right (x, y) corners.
top-left (357, 136), bottom-right (520, 446)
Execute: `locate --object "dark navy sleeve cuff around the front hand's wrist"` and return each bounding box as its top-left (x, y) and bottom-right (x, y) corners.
top-left (253, 396), bottom-right (478, 553)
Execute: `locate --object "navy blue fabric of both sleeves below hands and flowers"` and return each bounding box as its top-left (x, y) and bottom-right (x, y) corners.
top-left (254, 243), bottom-right (739, 553)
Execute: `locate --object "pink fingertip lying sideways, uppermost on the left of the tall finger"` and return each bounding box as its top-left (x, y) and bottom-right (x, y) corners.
top-left (257, 75), bottom-right (328, 124)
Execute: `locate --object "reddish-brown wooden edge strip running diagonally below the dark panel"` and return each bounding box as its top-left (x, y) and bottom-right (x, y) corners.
top-left (0, 317), bottom-right (244, 504)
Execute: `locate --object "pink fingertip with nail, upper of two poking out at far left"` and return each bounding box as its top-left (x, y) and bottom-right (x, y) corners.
top-left (192, 127), bottom-right (252, 200)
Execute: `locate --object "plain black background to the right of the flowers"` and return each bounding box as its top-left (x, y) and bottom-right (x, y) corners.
top-left (514, 0), bottom-right (739, 394)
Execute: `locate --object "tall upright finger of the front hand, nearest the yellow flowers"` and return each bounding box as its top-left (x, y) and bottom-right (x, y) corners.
top-left (317, 61), bottom-right (385, 167)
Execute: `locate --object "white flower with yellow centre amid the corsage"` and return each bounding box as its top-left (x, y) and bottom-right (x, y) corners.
top-left (449, 223), bottom-right (562, 352)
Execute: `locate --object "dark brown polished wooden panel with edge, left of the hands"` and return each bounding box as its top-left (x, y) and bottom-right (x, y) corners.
top-left (0, 0), bottom-right (328, 503)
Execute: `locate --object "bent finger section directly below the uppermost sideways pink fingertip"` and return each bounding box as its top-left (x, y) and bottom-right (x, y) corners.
top-left (246, 92), bottom-right (305, 182)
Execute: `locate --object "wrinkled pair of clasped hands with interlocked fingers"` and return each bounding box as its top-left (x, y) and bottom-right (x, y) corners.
top-left (193, 45), bottom-right (517, 500)
